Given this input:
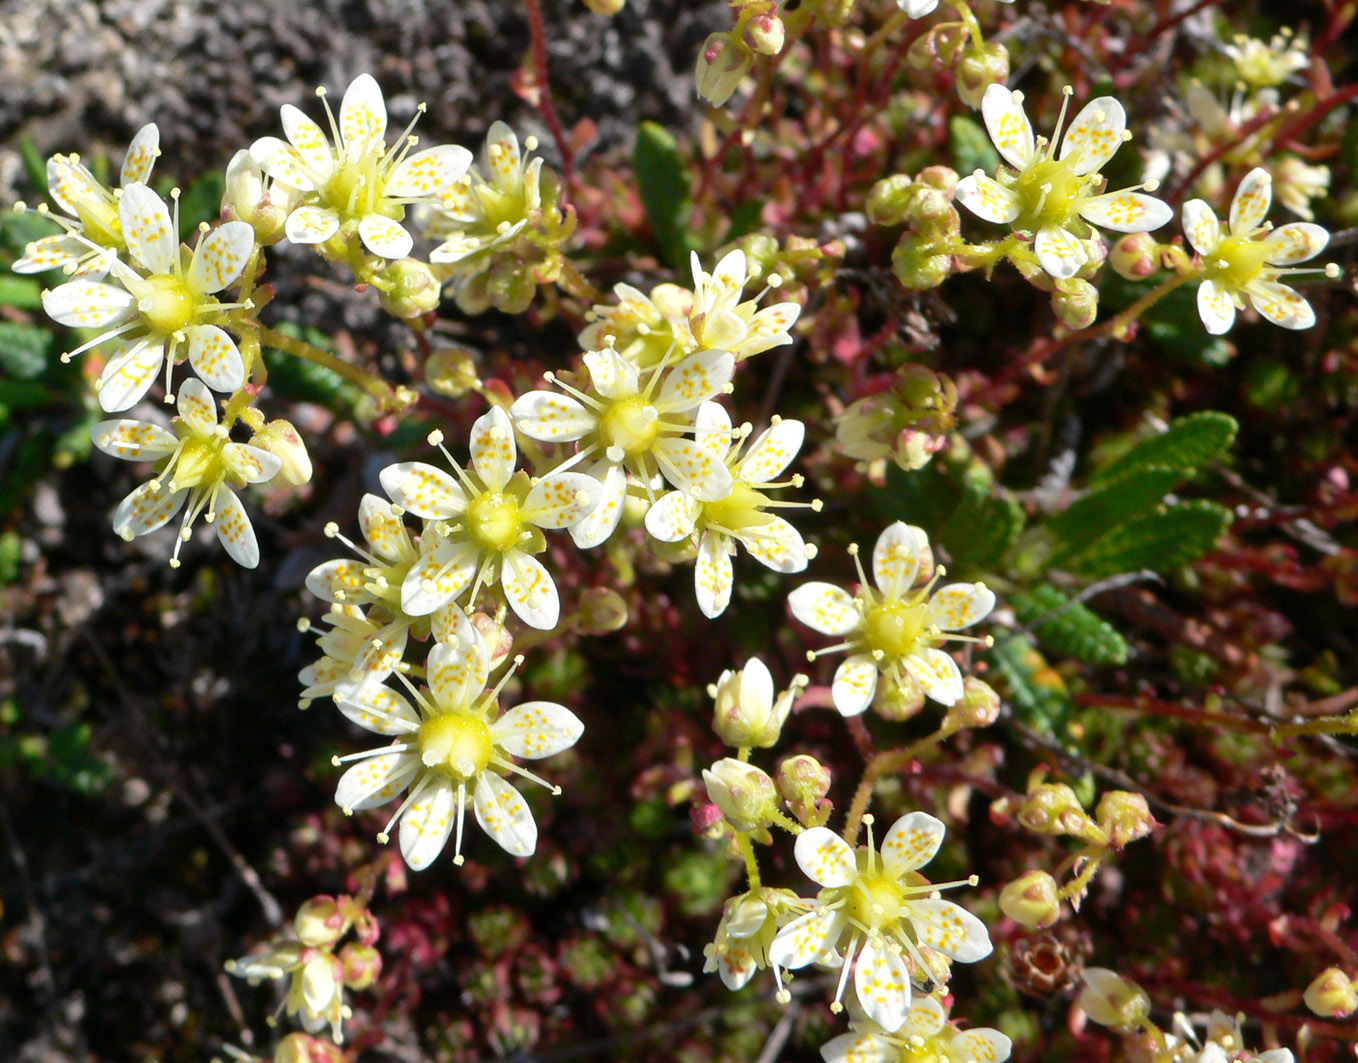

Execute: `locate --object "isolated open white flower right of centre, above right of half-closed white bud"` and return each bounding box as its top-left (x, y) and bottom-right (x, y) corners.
top-left (788, 521), bottom-right (995, 715)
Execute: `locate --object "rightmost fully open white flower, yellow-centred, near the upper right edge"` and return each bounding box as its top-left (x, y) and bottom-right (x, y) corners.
top-left (1183, 167), bottom-right (1336, 335)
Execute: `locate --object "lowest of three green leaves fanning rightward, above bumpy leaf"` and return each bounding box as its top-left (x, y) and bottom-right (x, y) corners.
top-left (1070, 500), bottom-right (1230, 580)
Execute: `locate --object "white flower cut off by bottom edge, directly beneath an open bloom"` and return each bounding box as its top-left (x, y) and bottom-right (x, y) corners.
top-left (820, 996), bottom-right (1013, 1063)
